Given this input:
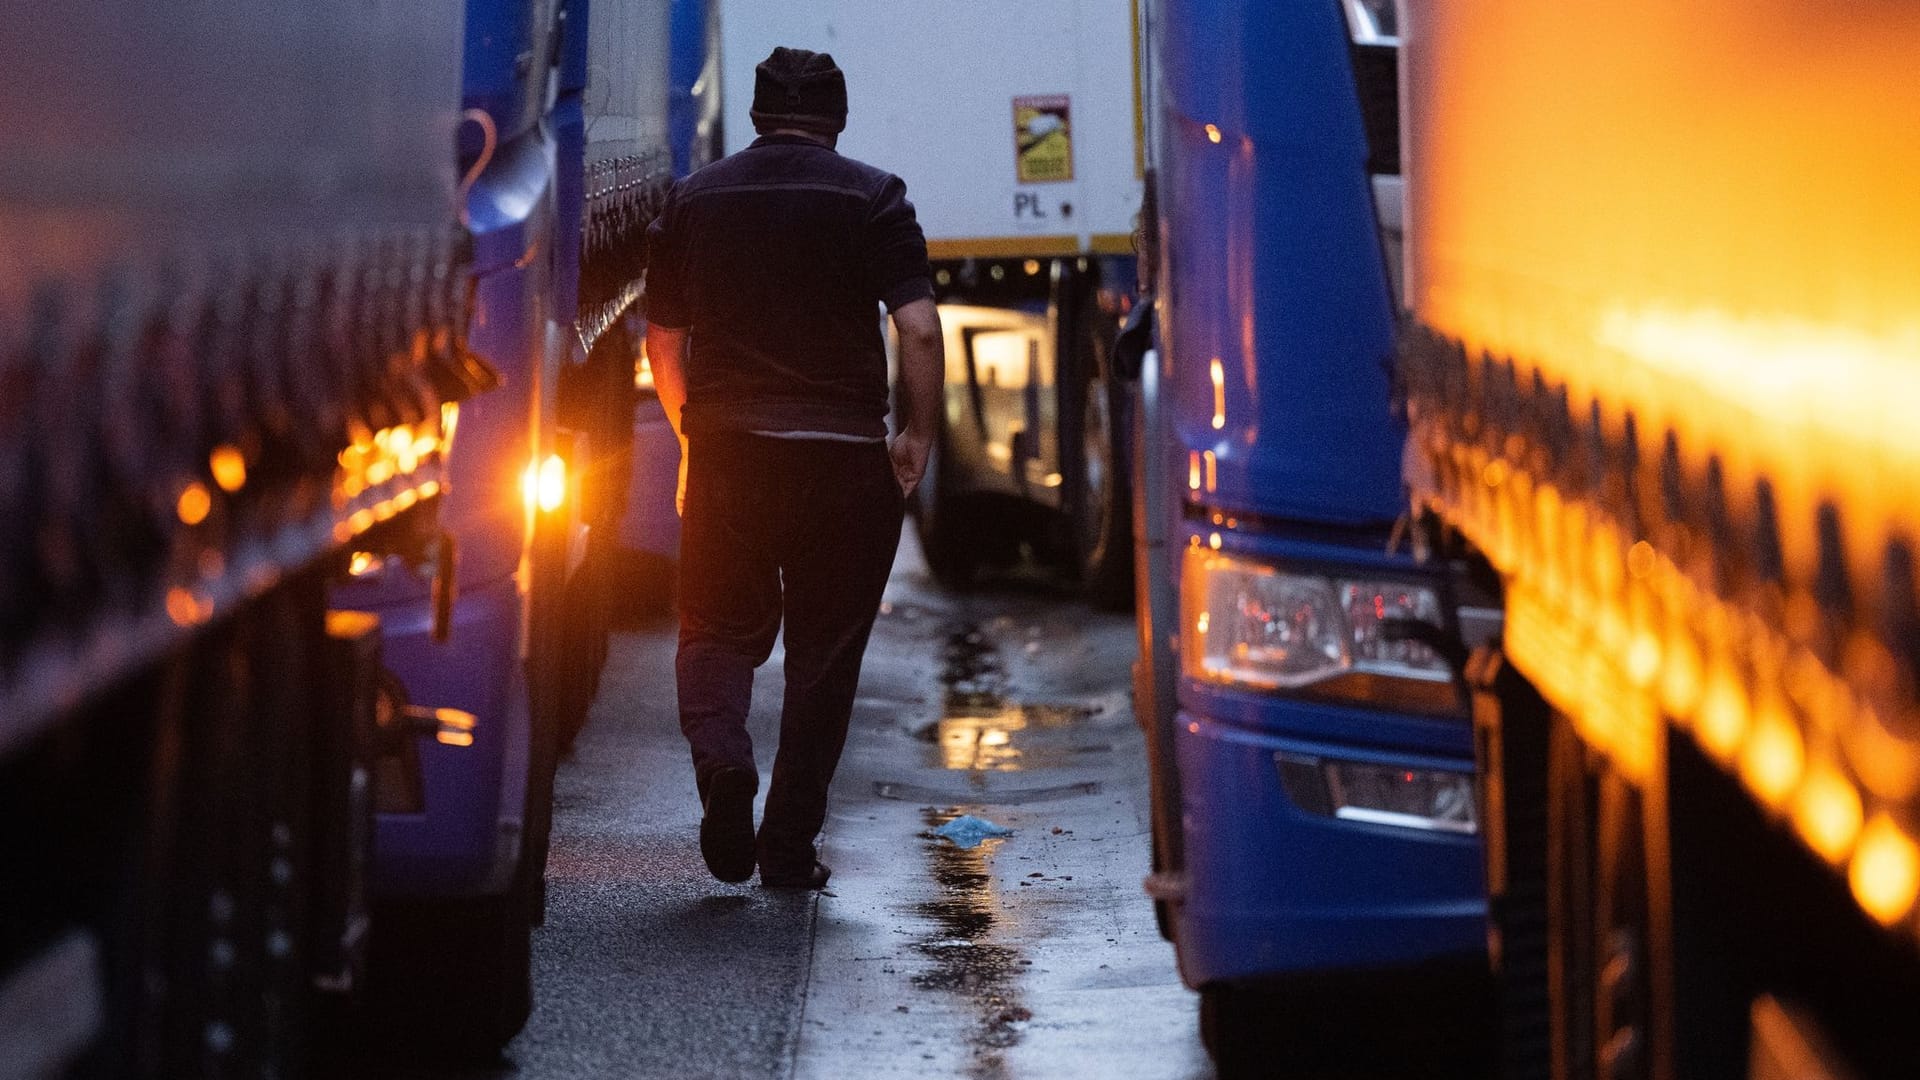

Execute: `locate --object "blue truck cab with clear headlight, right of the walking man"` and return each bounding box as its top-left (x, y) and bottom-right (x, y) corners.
top-left (1137, 0), bottom-right (1486, 1072)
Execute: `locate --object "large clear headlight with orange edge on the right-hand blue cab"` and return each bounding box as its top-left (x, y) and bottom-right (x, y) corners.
top-left (1181, 548), bottom-right (1459, 713)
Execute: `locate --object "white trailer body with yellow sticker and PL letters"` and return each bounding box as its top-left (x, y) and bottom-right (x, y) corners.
top-left (720, 0), bottom-right (1142, 259)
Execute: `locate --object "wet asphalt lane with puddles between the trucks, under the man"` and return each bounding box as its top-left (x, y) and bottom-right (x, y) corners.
top-left (347, 530), bottom-right (1212, 1080)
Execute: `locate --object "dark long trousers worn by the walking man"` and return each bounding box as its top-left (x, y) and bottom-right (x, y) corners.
top-left (674, 426), bottom-right (904, 872)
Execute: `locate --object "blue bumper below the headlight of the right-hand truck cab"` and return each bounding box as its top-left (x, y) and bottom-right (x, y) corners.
top-left (1175, 701), bottom-right (1486, 988)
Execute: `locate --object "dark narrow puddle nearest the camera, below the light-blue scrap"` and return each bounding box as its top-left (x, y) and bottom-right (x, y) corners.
top-left (914, 809), bottom-right (1033, 1080)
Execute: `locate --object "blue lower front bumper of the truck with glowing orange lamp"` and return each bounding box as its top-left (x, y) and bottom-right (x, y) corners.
top-left (372, 577), bottom-right (530, 897)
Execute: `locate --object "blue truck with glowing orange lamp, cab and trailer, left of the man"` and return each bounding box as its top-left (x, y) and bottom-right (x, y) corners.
top-left (334, 0), bottom-right (683, 1059)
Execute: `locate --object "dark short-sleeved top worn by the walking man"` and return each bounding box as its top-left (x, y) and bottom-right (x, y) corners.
top-left (647, 135), bottom-right (933, 436)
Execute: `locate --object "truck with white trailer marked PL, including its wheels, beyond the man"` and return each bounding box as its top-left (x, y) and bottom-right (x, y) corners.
top-left (720, 0), bottom-right (1140, 603)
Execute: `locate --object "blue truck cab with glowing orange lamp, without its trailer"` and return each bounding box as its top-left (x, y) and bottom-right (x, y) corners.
top-left (332, 0), bottom-right (586, 1055)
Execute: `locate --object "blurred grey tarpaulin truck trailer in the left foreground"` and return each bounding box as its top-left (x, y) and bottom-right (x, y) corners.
top-left (0, 0), bottom-right (476, 1078)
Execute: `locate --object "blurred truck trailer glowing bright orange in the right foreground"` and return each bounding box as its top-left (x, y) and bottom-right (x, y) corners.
top-left (1400, 0), bottom-right (1920, 1080)
